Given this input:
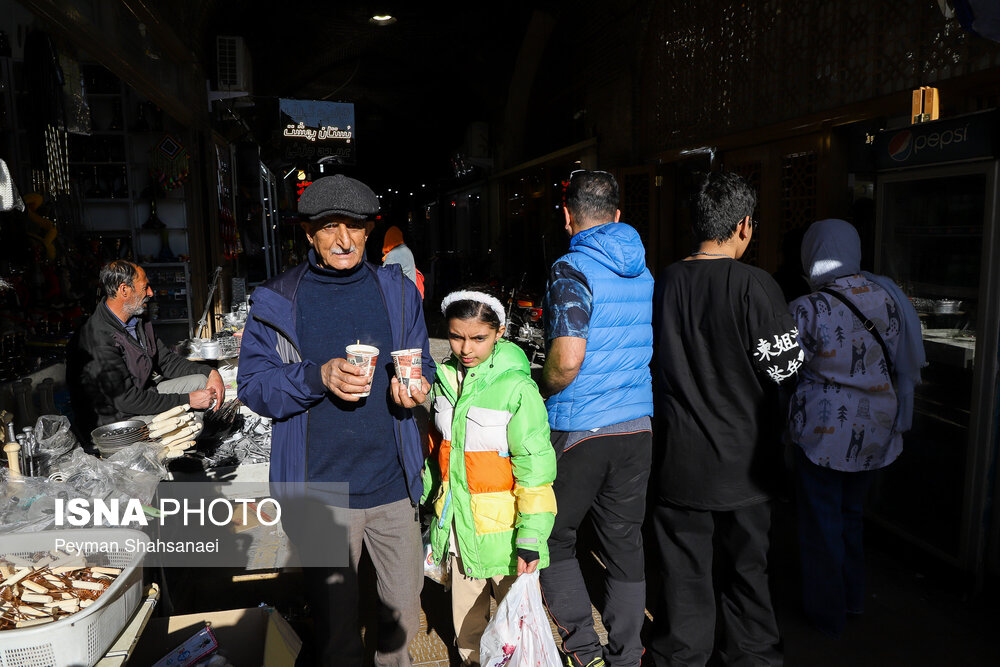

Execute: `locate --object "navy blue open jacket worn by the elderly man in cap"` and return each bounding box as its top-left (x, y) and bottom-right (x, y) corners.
top-left (237, 262), bottom-right (435, 502)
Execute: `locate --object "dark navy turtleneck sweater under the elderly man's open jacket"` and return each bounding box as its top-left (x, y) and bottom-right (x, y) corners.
top-left (296, 251), bottom-right (407, 509)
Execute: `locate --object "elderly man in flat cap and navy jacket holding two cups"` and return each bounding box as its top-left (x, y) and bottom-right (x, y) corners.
top-left (238, 175), bottom-right (435, 665)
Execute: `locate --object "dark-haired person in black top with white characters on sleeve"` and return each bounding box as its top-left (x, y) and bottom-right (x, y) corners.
top-left (650, 173), bottom-right (802, 667)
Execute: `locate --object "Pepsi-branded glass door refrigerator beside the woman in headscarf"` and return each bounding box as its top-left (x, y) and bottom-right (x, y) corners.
top-left (869, 112), bottom-right (1000, 576)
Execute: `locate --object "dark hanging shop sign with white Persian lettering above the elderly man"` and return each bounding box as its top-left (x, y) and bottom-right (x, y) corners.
top-left (278, 99), bottom-right (356, 164)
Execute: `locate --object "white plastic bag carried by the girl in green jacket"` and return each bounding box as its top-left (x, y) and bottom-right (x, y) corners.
top-left (479, 572), bottom-right (562, 667)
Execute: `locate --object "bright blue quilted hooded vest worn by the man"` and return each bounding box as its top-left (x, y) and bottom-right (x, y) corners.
top-left (545, 222), bottom-right (653, 431)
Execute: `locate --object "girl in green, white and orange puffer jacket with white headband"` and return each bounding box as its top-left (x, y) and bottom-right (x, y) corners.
top-left (424, 290), bottom-right (556, 665)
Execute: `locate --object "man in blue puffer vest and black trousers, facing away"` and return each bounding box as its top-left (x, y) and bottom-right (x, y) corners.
top-left (541, 170), bottom-right (653, 667)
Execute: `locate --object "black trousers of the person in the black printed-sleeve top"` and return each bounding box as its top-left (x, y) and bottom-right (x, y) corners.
top-left (649, 503), bottom-right (782, 667)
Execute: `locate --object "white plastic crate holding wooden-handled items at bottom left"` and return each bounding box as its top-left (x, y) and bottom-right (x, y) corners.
top-left (0, 528), bottom-right (149, 667)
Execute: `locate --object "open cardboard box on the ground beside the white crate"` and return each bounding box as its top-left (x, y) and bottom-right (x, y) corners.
top-left (128, 607), bottom-right (302, 667)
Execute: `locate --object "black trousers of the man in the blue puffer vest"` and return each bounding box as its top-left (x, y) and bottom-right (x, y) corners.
top-left (541, 431), bottom-right (652, 667)
